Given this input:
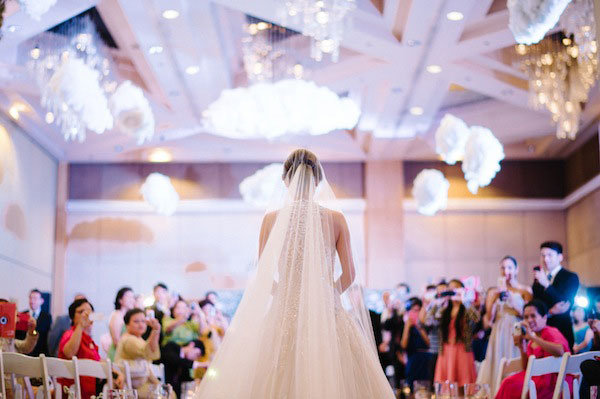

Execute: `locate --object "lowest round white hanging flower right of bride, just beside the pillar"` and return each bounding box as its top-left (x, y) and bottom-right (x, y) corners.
top-left (412, 169), bottom-right (450, 216)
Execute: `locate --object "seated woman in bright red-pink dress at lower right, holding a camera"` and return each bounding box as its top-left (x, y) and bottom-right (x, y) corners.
top-left (496, 299), bottom-right (573, 399)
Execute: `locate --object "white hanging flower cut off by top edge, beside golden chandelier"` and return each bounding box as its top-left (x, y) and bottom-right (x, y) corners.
top-left (506, 0), bottom-right (571, 44)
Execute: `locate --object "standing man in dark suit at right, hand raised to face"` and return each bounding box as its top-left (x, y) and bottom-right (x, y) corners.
top-left (532, 241), bottom-right (579, 348)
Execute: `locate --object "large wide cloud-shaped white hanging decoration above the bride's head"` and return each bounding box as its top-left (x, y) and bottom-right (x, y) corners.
top-left (204, 79), bottom-right (360, 139)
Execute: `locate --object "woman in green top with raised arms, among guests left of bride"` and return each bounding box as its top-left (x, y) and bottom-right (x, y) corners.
top-left (162, 299), bottom-right (207, 346)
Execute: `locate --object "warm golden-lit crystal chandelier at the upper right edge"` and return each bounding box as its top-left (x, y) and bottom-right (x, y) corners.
top-left (515, 0), bottom-right (598, 139)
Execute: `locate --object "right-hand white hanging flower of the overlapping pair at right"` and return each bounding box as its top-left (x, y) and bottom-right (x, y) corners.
top-left (462, 126), bottom-right (504, 194)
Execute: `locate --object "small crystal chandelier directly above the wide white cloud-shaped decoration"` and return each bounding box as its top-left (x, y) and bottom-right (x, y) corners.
top-left (242, 17), bottom-right (307, 83)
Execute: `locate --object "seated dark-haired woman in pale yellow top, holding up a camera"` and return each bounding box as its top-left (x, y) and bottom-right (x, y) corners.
top-left (115, 308), bottom-right (160, 399)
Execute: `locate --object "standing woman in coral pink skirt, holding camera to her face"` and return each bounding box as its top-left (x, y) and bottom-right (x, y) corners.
top-left (434, 280), bottom-right (480, 385)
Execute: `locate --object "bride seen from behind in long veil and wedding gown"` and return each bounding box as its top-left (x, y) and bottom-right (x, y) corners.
top-left (195, 149), bottom-right (394, 399)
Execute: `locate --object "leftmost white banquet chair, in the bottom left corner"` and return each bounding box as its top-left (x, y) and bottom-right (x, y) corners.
top-left (2, 352), bottom-right (50, 399)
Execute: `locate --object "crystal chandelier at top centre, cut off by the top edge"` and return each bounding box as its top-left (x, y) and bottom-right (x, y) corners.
top-left (285, 0), bottom-right (356, 62)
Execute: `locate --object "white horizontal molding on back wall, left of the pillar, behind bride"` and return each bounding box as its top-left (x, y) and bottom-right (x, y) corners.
top-left (67, 198), bottom-right (366, 215)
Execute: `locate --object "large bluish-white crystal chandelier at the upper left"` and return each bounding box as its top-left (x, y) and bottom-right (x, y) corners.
top-left (20, 17), bottom-right (117, 142)
